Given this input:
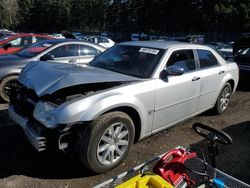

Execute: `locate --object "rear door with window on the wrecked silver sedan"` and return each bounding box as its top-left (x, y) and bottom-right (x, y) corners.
top-left (196, 49), bottom-right (225, 111)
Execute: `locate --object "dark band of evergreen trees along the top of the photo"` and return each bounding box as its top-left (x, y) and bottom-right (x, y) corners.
top-left (0, 0), bottom-right (250, 33)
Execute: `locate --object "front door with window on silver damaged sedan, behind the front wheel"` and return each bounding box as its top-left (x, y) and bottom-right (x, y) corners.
top-left (153, 50), bottom-right (200, 131)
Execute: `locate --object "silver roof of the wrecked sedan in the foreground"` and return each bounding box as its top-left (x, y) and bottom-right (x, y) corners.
top-left (118, 41), bottom-right (209, 49)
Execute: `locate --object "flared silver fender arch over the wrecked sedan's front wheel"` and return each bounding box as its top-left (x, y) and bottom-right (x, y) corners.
top-left (55, 94), bottom-right (147, 124)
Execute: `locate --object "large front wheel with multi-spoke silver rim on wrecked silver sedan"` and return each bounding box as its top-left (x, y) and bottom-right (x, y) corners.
top-left (79, 111), bottom-right (135, 173)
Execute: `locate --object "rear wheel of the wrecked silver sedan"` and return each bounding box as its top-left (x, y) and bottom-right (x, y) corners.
top-left (213, 82), bottom-right (232, 114)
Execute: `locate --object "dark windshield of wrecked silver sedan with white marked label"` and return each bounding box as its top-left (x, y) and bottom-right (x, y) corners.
top-left (89, 45), bottom-right (164, 78)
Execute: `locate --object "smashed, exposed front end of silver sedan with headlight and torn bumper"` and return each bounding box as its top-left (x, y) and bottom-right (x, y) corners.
top-left (9, 82), bottom-right (126, 151)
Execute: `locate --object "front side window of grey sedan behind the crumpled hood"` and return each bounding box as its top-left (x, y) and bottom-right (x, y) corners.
top-left (49, 44), bottom-right (78, 58)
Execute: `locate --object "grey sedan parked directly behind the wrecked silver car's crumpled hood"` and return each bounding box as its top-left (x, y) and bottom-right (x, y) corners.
top-left (0, 39), bottom-right (105, 102)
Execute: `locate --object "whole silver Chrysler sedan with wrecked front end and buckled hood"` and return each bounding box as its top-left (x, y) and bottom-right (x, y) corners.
top-left (9, 41), bottom-right (238, 173)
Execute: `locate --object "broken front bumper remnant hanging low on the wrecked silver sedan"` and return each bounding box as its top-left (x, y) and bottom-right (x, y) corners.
top-left (9, 106), bottom-right (47, 151)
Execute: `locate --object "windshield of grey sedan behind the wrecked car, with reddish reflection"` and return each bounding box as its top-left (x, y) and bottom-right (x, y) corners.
top-left (16, 40), bottom-right (56, 58)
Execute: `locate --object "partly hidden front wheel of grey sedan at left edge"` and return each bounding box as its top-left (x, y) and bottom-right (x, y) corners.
top-left (0, 75), bottom-right (18, 102)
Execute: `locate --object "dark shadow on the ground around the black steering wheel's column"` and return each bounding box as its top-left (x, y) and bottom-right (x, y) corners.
top-left (191, 121), bottom-right (250, 184)
